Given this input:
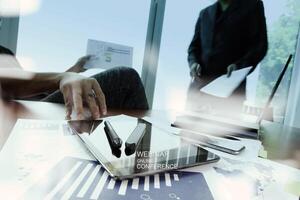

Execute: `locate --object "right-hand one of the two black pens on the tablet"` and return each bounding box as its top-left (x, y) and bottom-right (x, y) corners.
top-left (125, 123), bottom-right (146, 155)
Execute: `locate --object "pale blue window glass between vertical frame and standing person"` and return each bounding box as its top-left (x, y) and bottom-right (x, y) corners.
top-left (153, 0), bottom-right (213, 110)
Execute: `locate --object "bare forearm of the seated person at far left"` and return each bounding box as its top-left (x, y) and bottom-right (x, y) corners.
top-left (0, 73), bottom-right (65, 98)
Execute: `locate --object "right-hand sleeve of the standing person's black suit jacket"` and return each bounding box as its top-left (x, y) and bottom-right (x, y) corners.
top-left (235, 1), bottom-right (268, 68)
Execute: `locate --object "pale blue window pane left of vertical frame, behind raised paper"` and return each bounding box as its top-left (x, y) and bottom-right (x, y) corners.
top-left (17, 0), bottom-right (150, 72)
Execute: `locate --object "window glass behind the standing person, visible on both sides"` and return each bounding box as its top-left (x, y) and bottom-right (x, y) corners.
top-left (153, 0), bottom-right (300, 121)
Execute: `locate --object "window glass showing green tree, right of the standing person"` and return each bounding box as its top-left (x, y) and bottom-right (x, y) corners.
top-left (255, 0), bottom-right (300, 122)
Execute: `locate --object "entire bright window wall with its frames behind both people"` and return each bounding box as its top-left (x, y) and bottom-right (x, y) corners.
top-left (0, 0), bottom-right (300, 127)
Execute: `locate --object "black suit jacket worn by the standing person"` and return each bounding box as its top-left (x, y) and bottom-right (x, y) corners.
top-left (188, 0), bottom-right (268, 76)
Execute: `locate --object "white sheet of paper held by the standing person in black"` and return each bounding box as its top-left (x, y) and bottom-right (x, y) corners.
top-left (200, 67), bottom-right (252, 98)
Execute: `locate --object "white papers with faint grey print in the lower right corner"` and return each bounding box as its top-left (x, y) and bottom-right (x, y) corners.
top-left (209, 158), bottom-right (300, 200)
